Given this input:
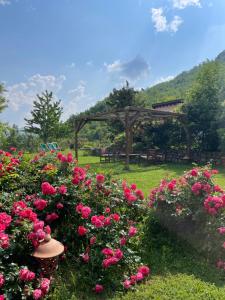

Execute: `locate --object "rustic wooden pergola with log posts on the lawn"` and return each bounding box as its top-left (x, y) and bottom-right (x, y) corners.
top-left (74, 106), bottom-right (190, 169)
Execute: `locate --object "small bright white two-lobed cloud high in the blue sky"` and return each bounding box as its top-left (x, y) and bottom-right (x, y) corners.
top-left (151, 7), bottom-right (183, 32)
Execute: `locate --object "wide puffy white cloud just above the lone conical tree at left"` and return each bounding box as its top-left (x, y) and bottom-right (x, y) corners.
top-left (6, 74), bottom-right (66, 111)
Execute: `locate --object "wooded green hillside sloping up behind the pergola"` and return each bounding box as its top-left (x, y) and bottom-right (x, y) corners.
top-left (70, 50), bottom-right (225, 147)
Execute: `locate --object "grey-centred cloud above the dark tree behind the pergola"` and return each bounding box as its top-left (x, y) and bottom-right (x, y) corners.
top-left (104, 56), bottom-right (150, 81)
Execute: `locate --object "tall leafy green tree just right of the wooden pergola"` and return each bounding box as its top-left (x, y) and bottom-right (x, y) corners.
top-left (183, 62), bottom-right (221, 151)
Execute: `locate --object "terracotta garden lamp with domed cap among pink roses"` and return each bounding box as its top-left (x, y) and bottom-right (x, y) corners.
top-left (32, 234), bottom-right (64, 278)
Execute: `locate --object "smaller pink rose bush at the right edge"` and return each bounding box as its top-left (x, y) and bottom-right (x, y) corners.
top-left (149, 165), bottom-right (225, 266)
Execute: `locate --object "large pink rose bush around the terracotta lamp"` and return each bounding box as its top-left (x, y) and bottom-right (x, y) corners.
top-left (0, 149), bottom-right (150, 300)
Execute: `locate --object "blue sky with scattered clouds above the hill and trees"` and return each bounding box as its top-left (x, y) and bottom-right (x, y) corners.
top-left (0, 0), bottom-right (225, 127)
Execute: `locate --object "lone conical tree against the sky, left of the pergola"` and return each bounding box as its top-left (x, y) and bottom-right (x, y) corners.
top-left (25, 91), bottom-right (63, 143)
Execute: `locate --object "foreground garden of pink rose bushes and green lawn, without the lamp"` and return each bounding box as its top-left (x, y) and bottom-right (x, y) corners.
top-left (0, 148), bottom-right (225, 299)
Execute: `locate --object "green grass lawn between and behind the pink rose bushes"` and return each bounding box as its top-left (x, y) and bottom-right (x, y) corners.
top-left (50, 152), bottom-right (225, 300)
